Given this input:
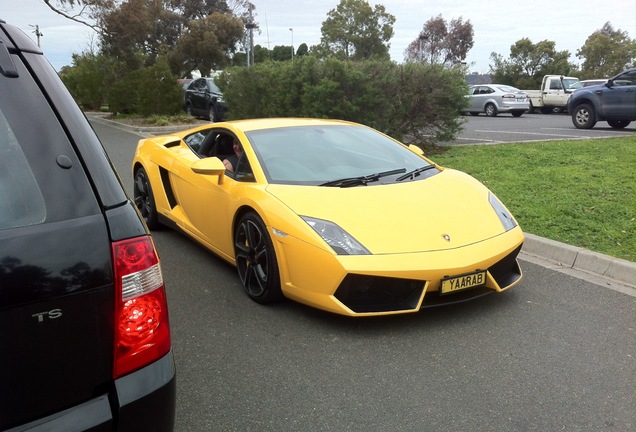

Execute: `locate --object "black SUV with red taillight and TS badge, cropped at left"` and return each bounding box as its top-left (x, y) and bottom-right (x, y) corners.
top-left (0, 20), bottom-right (176, 432)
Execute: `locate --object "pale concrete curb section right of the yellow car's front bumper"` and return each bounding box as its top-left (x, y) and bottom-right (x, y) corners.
top-left (522, 233), bottom-right (636, 288)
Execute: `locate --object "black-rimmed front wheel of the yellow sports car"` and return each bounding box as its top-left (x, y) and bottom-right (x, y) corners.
top-left (234, 212), bottom-right (283, 304)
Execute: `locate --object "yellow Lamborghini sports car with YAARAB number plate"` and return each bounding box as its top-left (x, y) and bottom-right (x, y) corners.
top-left (132, 119), bottom-right (524, 316)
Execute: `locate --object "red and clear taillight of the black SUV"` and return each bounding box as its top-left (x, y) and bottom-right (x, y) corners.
top-left (113, 236), bottom-right (171, 378)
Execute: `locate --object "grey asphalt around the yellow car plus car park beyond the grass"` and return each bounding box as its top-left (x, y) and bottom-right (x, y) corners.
top-left (94, 119), bottom-right (634, 432)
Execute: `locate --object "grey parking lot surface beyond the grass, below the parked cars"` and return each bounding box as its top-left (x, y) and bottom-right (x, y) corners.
top-left (444, 113), bottom-right (636, 145)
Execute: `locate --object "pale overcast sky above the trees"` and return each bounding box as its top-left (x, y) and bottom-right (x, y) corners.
top-left (0, 0), bottom-right (636, 73)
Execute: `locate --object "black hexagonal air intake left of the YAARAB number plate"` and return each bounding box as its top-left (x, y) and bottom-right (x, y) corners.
top-left (335, 274), bottom-right (425, 313)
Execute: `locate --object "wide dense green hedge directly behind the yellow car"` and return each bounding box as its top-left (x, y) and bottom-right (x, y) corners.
top-left (217, 56), bottom-right (467, 146)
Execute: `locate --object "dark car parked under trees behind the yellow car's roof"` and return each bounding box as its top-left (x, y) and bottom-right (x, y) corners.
top-left (185, 78), bottom-right (227, 122)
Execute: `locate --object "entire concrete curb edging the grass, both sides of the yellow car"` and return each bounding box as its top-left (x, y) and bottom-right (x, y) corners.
top-left (87, 113), bottom-right (636, 289)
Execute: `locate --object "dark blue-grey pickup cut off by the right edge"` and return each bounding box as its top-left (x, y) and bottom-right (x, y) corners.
top-left (568, 69), bottom-right (636, 129)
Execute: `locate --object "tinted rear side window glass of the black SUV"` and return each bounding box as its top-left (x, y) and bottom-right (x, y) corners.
top-left (0, 56), bottom-right (101, 230)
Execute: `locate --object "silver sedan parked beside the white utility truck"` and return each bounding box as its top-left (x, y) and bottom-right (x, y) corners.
top-left (462, 84), bottom-right (530, 117)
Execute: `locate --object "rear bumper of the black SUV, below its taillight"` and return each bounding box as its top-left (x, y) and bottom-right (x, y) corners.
top-left (6, 351), bottom-right (176, 432)
